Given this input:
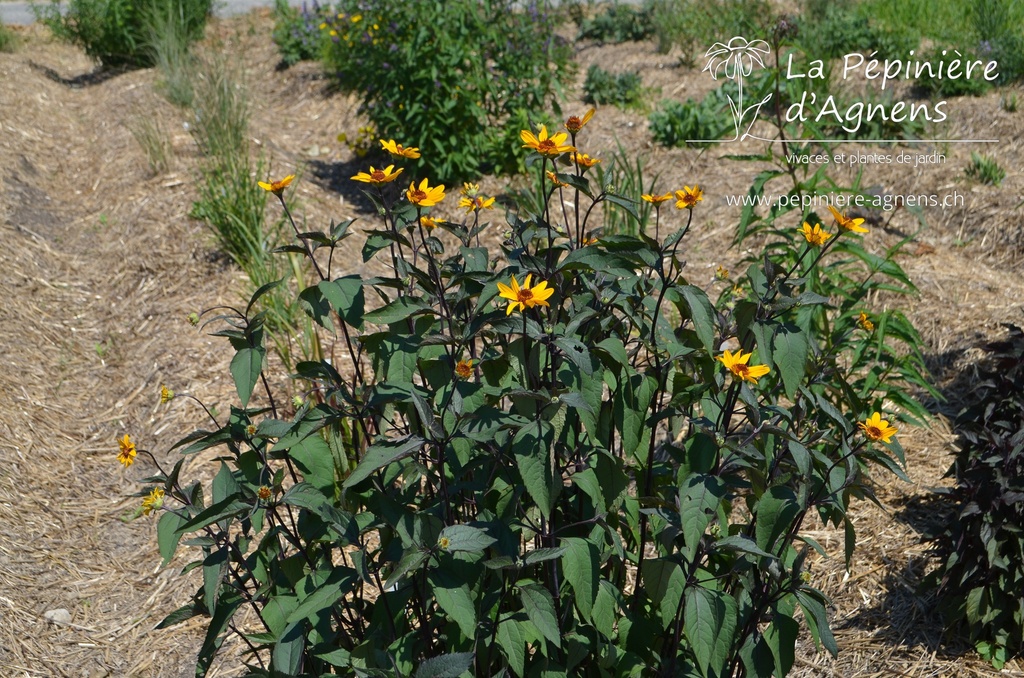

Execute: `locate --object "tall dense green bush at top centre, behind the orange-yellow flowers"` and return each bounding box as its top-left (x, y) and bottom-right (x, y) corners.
top-left (325, 0), bottom-right (572, 182)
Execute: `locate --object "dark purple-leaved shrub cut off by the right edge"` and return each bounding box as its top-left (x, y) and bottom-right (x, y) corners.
top-left (926, 325), bottom-right (1024, 669)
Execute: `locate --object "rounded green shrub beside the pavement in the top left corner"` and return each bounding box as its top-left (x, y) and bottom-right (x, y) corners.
top-left (35, 0), bottom-right (213, 67)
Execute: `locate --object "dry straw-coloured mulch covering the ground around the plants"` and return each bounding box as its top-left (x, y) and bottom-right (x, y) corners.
top-left (0, 11), bottom-right (1024, 678)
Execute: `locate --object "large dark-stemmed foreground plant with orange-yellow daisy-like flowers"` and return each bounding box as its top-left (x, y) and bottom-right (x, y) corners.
top-left (128, 102), bottom-right (937, 678)
